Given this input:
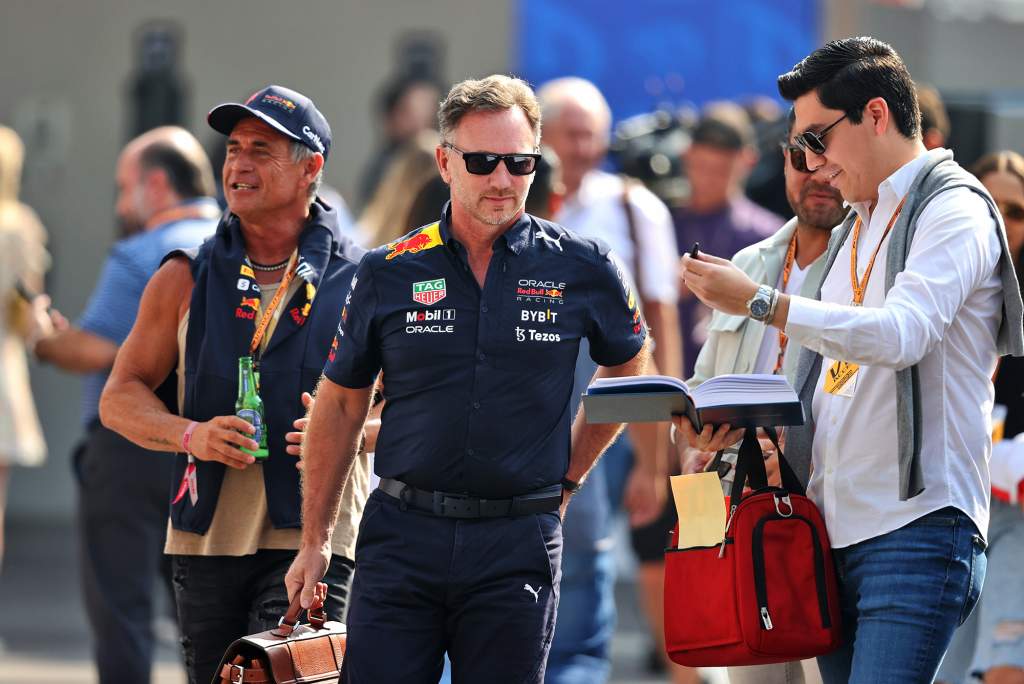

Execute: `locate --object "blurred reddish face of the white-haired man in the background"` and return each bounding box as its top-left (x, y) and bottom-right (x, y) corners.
top-left (544, 100), bottom-right (610, 192)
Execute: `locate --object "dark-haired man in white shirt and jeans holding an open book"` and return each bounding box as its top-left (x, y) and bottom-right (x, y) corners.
top-left (679, 38), bottom-right (1024, 684)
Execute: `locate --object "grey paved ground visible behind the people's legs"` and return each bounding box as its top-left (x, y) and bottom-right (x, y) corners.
top-left (0, 520), bottom-right (726, 684)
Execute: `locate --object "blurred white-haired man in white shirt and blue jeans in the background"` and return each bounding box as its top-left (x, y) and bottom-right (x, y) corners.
top-left (538, 78), bottom-right (682, 684)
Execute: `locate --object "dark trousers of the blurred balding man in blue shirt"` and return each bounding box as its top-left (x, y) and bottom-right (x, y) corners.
top-left (74, 423), bottom-right (173, 684)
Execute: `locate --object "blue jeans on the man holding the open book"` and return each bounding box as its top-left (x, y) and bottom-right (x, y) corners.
top-left (818, 508), bottom-right (985, 684)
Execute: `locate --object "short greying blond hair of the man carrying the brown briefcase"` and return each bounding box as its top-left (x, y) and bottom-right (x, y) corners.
top-left (437, 74), bottom-right (541, 144)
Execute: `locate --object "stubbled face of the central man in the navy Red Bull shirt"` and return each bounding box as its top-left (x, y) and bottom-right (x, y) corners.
top-left (437, 106), bottom-right (537, 226)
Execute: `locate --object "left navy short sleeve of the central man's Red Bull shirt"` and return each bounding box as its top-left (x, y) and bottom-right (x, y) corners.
top-left (324, 258), bottom-right (381, 389)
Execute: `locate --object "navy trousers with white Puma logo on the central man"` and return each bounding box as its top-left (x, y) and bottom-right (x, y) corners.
top-left (343, 489), bottom-right (562, 684)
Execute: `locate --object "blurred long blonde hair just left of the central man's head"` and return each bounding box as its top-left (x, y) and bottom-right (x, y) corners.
top-left (359, 131), bottom-right (437, 247)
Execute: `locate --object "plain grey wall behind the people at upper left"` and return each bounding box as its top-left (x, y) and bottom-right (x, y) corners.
top-left (0, 0), bottom-right (513, 519)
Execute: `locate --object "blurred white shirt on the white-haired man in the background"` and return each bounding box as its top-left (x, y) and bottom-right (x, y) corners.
top-left (555, 169), bottom-right (679, 304)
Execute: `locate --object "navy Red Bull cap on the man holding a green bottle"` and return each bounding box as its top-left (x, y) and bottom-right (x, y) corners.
top-left (206, 85), bottom-right (331, 159)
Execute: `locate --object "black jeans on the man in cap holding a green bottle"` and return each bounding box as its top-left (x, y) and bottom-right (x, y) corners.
top-left (172, 550), bottom-right (352, 684)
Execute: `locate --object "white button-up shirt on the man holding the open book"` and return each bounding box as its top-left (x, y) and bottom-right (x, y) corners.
top-left (785, 150), bottom-right (1002, 548)
